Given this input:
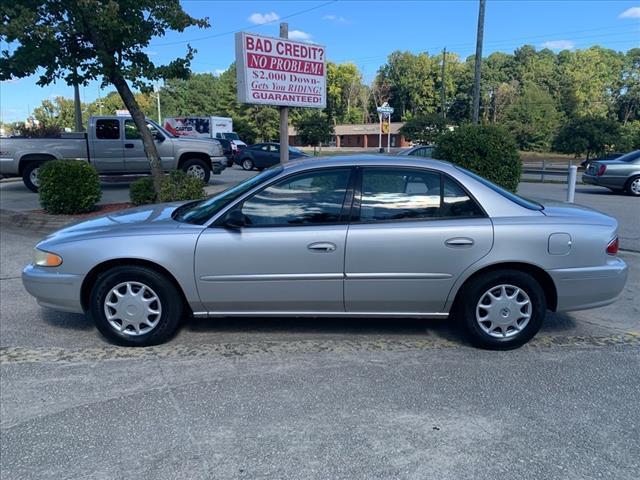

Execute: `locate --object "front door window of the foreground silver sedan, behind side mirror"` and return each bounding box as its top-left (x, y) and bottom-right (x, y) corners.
top-left (242, 169), bottom-right (350, 226)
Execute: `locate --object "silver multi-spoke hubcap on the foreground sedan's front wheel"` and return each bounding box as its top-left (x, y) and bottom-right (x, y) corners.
top-left (104, 282), bottom-right (162, 336)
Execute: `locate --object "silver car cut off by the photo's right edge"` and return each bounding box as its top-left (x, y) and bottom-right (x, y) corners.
top-left (582, 150), bottom-right (640, 197)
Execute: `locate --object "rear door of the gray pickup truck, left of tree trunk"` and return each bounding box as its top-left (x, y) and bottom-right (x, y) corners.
top-left (90, 118), bottom-right (124, 173)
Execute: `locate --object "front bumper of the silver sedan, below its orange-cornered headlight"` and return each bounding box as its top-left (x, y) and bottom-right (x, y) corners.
top-left (22, 265), bottom-right (84, 313)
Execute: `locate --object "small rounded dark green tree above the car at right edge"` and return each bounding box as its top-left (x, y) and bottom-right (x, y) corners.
top-left (554, 117), bottom-right (620, 160)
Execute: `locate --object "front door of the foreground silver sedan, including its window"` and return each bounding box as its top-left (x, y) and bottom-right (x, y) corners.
top-left (195, 168), bottom-right (351, 314)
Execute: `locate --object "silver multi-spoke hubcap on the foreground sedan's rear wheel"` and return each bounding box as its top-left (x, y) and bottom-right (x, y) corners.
top-left (476, 285), bottom-right (531, 338)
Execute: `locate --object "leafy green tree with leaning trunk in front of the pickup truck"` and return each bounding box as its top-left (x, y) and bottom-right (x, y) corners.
top-left (0, 0), bottom-right (209, 199)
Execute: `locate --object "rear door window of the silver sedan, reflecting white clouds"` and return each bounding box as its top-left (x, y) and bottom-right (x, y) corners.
top-left (360, 169), bottom-right (441, 222)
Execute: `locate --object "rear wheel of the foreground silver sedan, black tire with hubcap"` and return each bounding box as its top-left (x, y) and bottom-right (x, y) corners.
top-left (457, 270), bottom-right (547, 350)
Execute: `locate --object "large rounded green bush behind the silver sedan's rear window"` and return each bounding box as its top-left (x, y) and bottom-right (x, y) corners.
top-left (433, 124), bottom-right (522, 192)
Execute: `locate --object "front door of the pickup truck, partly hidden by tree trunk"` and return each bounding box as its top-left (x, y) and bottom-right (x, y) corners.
top-left (124, 119), bottom-right (173, 173)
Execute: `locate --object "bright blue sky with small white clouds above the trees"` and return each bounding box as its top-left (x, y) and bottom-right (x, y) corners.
top-left (0, 0), bottom-right (640, 122)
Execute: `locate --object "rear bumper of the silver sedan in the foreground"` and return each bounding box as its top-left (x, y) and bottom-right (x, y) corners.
top-left (548, 257), bottom-right (628, 312)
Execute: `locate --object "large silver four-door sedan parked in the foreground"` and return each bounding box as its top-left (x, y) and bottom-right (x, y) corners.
top-left (23, 156), bottom-right (627, 349)
